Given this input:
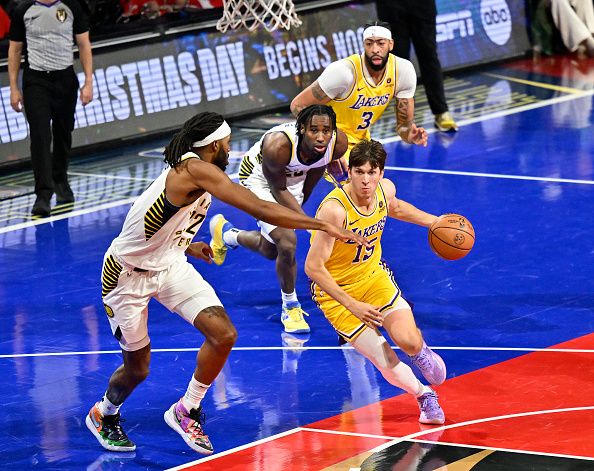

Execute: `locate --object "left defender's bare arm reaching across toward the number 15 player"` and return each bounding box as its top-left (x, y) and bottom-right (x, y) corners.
top-left (188, 159), bottom-right (369, 247)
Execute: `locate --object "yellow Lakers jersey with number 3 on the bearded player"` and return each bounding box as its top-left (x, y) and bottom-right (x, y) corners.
top-left (328, 54), bottom-right (398, 149)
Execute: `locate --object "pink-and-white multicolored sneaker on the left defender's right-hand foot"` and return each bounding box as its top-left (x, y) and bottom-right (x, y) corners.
top-left (164, 399), bottom-right (213, 455)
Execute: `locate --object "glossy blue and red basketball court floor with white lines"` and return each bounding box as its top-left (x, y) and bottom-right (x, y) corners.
top-left (0, 52), bottom-right (594, 471)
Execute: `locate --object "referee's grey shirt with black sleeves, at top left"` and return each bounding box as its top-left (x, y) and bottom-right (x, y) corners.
top-left (9, 0), bottom-right (89, 72)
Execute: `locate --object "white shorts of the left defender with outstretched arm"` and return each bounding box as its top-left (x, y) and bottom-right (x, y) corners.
top-left (101, 252), bottom-right (222, 351)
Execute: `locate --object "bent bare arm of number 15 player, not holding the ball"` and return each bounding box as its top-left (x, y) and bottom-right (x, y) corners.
top-left (305, 201), bottom-right (383, 328)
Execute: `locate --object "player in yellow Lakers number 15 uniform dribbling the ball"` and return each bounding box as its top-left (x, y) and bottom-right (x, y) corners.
top-left (305, 140), bottom-right (446, 424)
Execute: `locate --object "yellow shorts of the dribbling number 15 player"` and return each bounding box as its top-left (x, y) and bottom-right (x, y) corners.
top-left (311, 262), bottom-right (402, 342)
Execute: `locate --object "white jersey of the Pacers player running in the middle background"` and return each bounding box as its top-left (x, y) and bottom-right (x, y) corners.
top-left (239, 122), bottom-right (336, 204)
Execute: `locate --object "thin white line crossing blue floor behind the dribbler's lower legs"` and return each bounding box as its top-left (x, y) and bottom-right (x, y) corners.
top-left (0, 347), bottom-right (594, 359)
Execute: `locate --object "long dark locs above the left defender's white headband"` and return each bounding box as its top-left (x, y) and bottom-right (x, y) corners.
top-left (163, 111), bottom-right (225, 168)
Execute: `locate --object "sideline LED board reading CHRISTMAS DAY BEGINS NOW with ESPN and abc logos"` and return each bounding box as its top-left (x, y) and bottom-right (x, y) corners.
top-left (0, 0), bottom-right (528, 166)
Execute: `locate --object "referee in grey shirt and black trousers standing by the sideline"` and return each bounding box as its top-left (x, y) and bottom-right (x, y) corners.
top-left (8, 0), bottom-right (93, 216)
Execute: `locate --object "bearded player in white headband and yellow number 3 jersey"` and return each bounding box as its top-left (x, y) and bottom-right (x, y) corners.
top-left (291, 21), bottom-right (427, 181)
